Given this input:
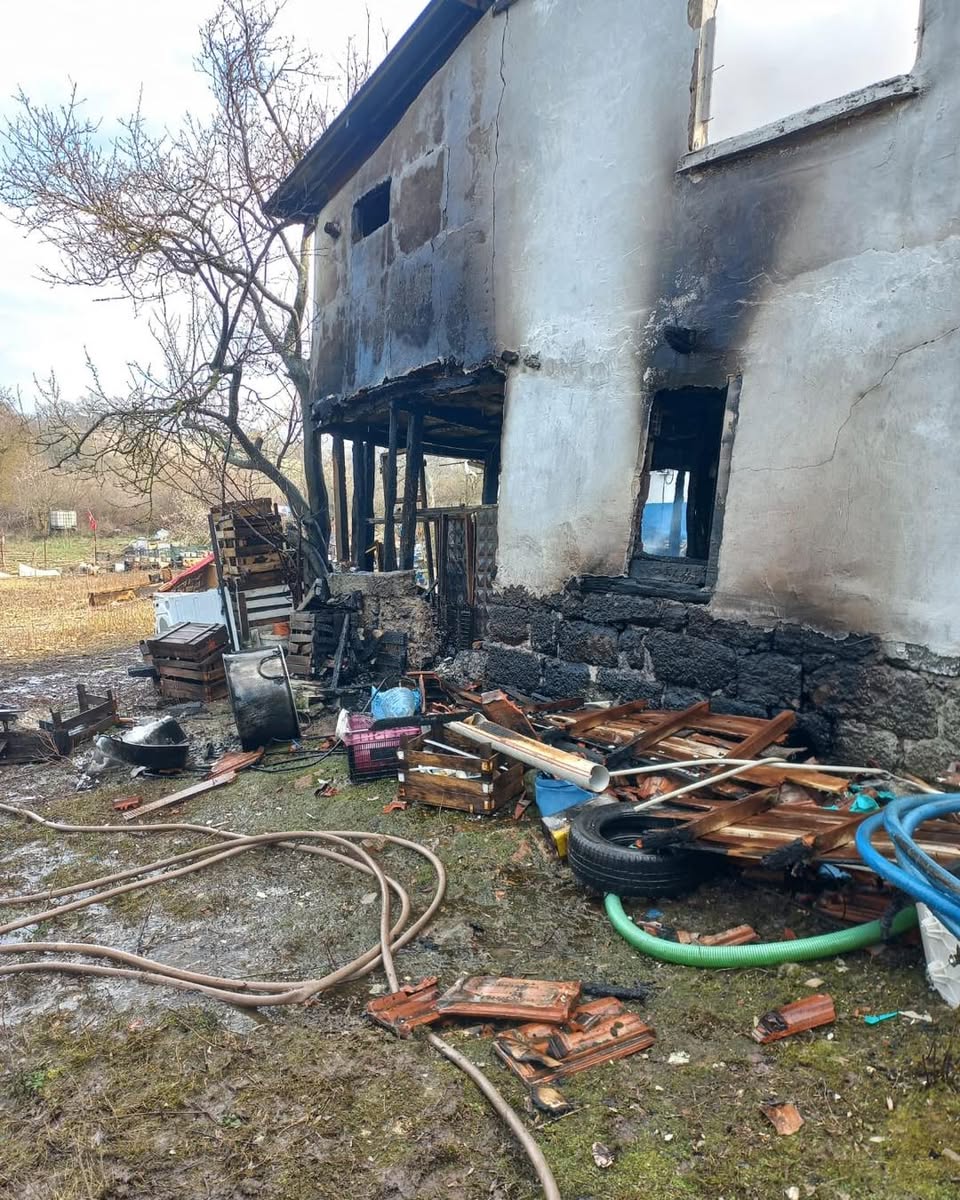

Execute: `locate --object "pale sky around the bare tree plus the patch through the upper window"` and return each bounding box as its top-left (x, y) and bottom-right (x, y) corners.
top-left (0, 0), bottom-right (919, 406)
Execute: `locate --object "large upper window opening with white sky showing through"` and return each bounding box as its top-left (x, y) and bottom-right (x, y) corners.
top-left (691, 0), bottom-right (923, 150)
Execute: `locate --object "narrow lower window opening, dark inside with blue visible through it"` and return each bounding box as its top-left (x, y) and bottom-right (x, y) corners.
top-left (640, 388), bottom-right (726, 563)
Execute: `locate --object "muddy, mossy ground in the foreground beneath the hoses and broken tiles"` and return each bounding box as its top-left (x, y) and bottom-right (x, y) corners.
top-left (0, 653), bottom-right (960, 1200)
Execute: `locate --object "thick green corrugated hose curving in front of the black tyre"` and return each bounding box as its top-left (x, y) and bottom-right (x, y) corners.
top-left (604, 895), bottom-right (917, 971)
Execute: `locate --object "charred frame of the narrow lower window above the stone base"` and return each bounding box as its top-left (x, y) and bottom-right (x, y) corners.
top-left (628, 376), bottom-right (742, 600)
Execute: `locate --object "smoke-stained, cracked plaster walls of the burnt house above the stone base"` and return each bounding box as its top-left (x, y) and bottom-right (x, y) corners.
top-left (314, 0), bottom-right (960, 655)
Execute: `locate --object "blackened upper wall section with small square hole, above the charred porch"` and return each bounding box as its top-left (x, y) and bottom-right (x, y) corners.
top-left (312, 18), bottom-right (500, 398)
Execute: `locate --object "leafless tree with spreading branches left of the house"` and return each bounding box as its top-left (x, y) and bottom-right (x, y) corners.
top-left (0, 0), bottom-right (370, 574)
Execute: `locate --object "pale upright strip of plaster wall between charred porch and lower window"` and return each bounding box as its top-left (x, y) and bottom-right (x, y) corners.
top-left (494, 0), bottom-right (696, 593)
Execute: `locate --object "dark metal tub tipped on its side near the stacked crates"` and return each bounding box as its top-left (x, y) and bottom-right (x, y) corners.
top-left (223, 647), bottom-right (300, 750)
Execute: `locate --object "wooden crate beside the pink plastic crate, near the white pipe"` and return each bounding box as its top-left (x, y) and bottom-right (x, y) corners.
top-left (397, 728), bottom-right (523, 814)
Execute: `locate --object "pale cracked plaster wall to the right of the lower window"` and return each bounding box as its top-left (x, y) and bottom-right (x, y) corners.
top-left (701, 0), bottom-right (960, 654)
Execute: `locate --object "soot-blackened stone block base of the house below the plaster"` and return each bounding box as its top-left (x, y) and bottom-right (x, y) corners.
top-left (485, 583), bottom-right (960, 779)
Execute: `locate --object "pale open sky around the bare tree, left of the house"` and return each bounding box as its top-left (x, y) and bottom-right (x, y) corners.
top-left (0, 0), bottom-right (426, 407)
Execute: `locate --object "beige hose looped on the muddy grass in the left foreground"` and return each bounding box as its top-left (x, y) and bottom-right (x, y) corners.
top-left (0, 804), bottom-right (560, 1200)
